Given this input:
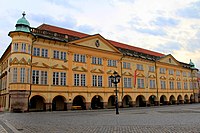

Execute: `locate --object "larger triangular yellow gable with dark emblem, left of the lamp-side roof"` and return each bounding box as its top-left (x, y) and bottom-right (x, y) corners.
top-left (70, 34), bottom-right (120, 53)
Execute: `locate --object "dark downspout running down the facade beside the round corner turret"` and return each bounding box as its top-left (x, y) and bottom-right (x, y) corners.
top-left (27, 34), bottom-right (37, 112)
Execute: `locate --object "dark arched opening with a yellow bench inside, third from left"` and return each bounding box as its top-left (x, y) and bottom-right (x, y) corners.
top-left (72, 95), bottom-right (86, 110)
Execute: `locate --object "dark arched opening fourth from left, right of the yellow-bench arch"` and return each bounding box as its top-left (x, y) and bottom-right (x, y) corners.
top-left (91, 95), bottom-right (103, 109)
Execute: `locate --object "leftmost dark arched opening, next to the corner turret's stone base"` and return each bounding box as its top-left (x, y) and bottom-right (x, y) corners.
top-left (29, 95), bottom-right (46, 111)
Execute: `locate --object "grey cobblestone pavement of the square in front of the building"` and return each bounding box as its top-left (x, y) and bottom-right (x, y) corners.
top-left (0, 104), bottom-right (200, 133)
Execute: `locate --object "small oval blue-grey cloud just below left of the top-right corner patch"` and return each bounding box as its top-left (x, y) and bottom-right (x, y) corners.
top-left (150, 17), bottom-right (180, 27)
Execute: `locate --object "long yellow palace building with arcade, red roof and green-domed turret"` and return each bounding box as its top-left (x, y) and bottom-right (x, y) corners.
top-left (0, 13), bottom-right (199, 112)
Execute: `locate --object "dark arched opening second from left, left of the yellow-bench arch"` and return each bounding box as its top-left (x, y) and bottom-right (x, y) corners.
top-left (52, 96), bottom-right (67, 111)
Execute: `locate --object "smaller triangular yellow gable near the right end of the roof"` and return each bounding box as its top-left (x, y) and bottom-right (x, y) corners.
top-left (159, 54), bottom-right (180, 66)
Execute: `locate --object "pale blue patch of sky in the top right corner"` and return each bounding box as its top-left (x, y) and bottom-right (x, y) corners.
top-left (177, 1), bottom-right (200, 19)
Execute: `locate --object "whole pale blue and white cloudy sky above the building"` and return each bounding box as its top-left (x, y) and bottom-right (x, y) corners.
top-left (0, 0), bottom-right (200, 69)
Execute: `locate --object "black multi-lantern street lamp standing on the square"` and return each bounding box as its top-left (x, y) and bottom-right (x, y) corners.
top-left (109, 71), bottom-right (121, 114)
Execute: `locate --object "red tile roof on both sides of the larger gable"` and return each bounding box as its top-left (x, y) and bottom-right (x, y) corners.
top-left (38, 24), bottom-right (164, 56)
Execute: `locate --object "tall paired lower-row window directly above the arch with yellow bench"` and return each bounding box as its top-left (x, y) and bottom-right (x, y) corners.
top-left (74, 74), bottom-right (86, 86)
